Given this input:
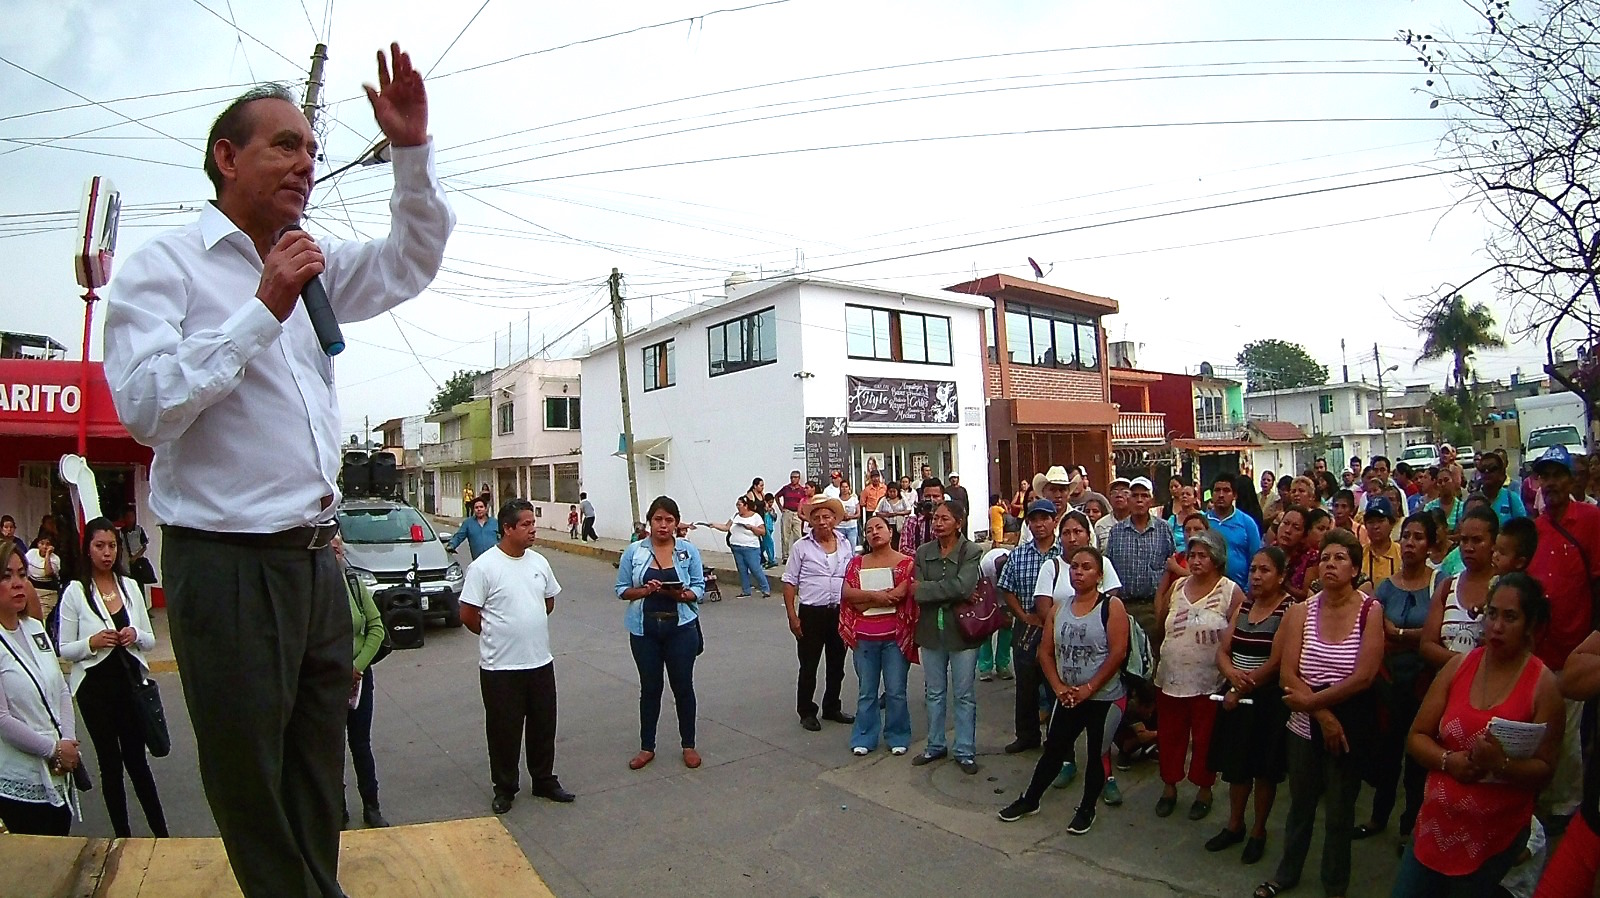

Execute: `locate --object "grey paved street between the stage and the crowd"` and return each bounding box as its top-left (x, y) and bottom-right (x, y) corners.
top-left (75, 551), bottom-right (1395, 898)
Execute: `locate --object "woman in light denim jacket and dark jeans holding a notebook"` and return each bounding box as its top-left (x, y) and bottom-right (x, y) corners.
top-left (616, 496), bottom-right (706, 770)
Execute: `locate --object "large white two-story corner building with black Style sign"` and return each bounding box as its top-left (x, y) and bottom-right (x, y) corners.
top-left (582, 275), bottom-right (992, 549)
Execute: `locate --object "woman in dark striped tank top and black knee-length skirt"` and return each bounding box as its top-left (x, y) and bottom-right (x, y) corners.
top-left (1205, 547), bottom-right (1291, 864)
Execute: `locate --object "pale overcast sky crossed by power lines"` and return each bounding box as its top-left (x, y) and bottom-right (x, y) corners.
top-left (0, 0), bottom-right (1561, 432)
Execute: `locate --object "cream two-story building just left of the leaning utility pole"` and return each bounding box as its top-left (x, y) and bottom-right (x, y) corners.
top-left (490, 359), bottom-right (582, 530)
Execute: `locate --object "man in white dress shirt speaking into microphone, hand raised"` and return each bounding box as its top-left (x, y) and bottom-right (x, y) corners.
top-left (106, 45), bottom-right (454, 898)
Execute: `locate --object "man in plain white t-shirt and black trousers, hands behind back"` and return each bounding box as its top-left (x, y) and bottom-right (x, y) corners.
top-left (461, 499), bottom-right (573, 813)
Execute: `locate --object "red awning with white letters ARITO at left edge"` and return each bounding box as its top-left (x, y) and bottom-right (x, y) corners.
top-left (0, 359), bottom-right (133, 439)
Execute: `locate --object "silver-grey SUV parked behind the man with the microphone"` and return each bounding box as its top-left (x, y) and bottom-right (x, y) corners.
top-left (339, 498), bottom-right (462, 627)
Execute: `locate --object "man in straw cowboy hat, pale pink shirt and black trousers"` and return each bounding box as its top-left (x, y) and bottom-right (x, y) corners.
top-left (784, 495), bottom-right (856, 732)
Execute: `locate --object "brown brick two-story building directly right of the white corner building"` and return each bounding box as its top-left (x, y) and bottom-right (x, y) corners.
top-left (949, 274), bottom-right (1117, 498)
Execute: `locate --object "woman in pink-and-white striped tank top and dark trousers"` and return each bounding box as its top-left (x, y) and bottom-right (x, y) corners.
top-left (1254, 530), bottom-right (1384, 898)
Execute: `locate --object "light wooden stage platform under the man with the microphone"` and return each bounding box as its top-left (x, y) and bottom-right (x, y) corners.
top-left (0, 816), bottom-right (550, 898)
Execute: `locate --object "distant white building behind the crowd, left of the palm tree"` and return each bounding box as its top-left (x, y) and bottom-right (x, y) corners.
top-left (1245, 381), bottom-right (1418, 471)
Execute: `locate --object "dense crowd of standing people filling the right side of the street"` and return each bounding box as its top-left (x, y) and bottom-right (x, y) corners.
top-left (662, 447), bottom-right (1600, 898)
